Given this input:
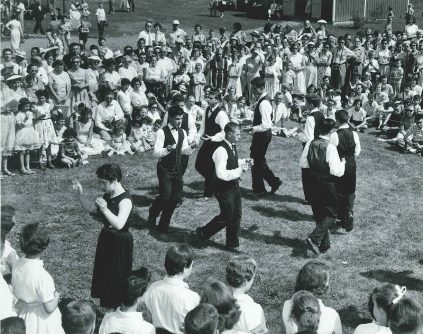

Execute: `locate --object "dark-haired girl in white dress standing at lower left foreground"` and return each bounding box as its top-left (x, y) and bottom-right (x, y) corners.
top-left (12, 223), bottom-right (64, 334)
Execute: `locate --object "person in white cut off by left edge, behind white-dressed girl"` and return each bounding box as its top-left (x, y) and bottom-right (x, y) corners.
top-left (0, 205), bottom-right (19, 283)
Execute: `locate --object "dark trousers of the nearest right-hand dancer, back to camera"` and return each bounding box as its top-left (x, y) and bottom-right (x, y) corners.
top-left (309, 175), bottom-right (338, 250)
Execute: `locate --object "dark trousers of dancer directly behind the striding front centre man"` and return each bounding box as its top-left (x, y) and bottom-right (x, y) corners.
top-left (195, 140), bottom-right (218, 197)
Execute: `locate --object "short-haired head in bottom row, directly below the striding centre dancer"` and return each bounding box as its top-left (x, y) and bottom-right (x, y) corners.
top-left (226, 255), bottom-right (257, 288)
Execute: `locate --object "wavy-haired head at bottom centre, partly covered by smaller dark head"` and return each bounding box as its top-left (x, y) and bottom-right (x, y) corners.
top-left (201, 280), bottom-right (241, 332)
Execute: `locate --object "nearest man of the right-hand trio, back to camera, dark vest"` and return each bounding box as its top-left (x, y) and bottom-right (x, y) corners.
top-left (300, 118), bottom-right (345, 255)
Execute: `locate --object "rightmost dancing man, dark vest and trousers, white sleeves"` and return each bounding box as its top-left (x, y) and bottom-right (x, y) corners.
top-left (329, 110), bottom-right (361, 232)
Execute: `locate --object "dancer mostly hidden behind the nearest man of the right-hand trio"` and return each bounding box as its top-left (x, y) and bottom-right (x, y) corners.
top-left (301, 94), bottom-right (325, 202)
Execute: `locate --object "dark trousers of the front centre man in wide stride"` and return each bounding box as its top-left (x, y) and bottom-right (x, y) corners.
top-left (200, 188), bottom-right (242, 247)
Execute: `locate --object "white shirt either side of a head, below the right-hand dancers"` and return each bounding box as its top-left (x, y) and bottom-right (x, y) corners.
top-left (282, 299), bottom-right (342, 334)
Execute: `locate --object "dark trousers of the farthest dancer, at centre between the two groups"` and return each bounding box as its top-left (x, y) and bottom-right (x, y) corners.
top-left (250, 130), bottom-right (279, 193)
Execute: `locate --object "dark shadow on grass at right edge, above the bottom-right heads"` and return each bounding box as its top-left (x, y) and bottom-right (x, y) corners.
top-left (360, 269), bottom-right (423, 291)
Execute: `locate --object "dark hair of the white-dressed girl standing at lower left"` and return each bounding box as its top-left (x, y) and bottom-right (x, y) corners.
top-left (19, 223), bottom-right (50, 255)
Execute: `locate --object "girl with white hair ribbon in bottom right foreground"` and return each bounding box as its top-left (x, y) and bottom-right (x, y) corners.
top-left (354, 284), bottom-right (398, 334)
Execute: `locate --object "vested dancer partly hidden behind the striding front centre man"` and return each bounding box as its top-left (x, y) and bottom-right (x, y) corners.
top-left (195, 90), bottom-right (229, 199)
